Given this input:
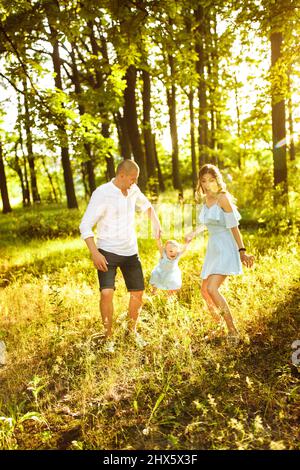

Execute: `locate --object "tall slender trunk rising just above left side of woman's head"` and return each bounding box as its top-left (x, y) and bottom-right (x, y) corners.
top-left (195, 5), bottom-right (209, 167)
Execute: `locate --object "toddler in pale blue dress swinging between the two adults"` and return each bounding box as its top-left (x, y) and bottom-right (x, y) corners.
top-left (149, 239), bottom-right (189, 295)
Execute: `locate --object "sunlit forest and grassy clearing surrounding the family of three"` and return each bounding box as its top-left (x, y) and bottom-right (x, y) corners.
top-left (0, 0), bottom-right (300, 452)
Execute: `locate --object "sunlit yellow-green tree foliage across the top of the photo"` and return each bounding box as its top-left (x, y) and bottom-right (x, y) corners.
top-left (1, 0), bottom-right (299, 210)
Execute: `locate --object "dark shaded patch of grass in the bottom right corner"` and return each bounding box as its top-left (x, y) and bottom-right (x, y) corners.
top-left (154, 283), bottom-right (300, 449)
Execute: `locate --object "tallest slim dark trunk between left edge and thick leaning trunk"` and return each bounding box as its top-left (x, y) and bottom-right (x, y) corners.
top-left (23, 77), bottom-right (41, 202)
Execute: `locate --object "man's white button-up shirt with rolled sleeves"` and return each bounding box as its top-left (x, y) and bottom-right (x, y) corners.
top-left (79, 179), bottom-right (151, 256)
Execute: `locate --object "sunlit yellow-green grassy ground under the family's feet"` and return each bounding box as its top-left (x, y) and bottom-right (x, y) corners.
top-left (0, 203), bottom-right (300, 449)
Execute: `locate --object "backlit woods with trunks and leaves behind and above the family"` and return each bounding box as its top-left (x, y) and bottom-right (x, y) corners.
top-left (0, 0), bottom-right (300, 213)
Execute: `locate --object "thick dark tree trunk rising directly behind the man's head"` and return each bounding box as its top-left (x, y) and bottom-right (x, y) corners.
top-left (124, 65), bottom-right (147, 191)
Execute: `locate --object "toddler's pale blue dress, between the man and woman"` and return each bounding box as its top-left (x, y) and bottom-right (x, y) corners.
top-left (149, 250), bottom-right (182, 290)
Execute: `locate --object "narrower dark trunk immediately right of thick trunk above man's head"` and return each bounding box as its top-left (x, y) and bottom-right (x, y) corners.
top-left (142, 70), bottom-right (157, 183)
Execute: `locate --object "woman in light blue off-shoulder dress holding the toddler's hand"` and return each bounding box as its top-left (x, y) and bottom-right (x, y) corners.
top-left (186, 164), bottom-right (254, 342)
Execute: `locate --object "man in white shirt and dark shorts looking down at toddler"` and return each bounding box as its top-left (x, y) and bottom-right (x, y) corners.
top-left (80, 160), bottom-right (161, 337)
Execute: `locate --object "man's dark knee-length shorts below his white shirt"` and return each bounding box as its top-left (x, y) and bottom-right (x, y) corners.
top-left (98, 248), bottom-right (145, 292)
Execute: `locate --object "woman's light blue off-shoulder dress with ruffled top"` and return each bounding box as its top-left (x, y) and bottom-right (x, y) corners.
top-left (199, 203), bottom-right (243, 279)
